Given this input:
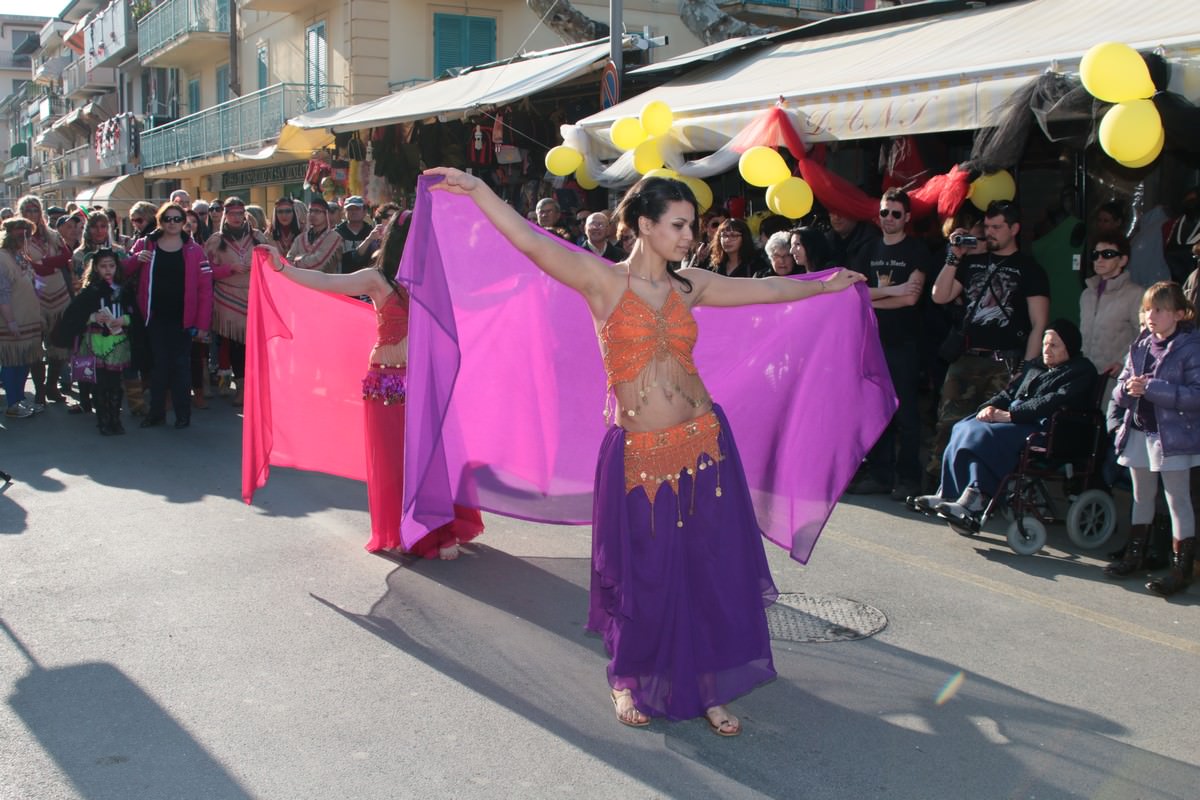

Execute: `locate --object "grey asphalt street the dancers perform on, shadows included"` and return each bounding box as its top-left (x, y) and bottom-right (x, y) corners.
top-left (0, 399), bottom-right (1200, 800)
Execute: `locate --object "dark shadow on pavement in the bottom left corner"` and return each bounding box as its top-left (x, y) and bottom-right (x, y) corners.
top-left (0, 621), bottom-right (250, 800)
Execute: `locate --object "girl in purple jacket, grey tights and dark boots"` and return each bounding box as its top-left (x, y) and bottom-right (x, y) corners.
top-left (1104, 281), bottom-right (1200, 597)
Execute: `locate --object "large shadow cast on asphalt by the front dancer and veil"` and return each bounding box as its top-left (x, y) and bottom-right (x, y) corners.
top-left (314, 545), bottom-right (1200, 800)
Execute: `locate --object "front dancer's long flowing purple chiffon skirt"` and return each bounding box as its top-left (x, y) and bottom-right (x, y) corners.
top-left (587, 405), bottom-right (779, 720)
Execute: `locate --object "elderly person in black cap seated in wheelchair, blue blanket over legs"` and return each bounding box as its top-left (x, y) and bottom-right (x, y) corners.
top-left (911, 319), bottom-right (1097, 529)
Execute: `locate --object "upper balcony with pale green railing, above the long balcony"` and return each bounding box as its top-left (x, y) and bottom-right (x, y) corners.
top-left (138, 0), bottom-right (230, 68)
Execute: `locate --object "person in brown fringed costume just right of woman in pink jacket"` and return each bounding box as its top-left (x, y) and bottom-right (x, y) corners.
top-left (196, 197), bottom-right (266, 408)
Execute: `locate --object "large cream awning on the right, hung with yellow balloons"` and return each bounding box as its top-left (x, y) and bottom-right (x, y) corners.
top-left (578, 0), bottom-right (1200, 151)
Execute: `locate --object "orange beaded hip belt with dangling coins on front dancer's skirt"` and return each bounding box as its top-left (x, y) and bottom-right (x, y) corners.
top-left (625, 411), bottom-right (721, 505)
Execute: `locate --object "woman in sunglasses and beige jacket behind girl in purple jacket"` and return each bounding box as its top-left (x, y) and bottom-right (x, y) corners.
top-left (1079, 233), bottom-right (1145, 397)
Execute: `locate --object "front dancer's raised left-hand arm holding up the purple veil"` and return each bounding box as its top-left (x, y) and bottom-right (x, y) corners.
top-left (425, 167), bottom-right (612, 305)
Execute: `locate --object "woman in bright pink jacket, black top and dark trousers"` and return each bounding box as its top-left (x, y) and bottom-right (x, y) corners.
top-left (125, 203), bottom-right (212, 428)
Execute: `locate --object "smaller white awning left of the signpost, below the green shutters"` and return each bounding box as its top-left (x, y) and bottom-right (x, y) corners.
top-left (288, 41), bottom-right (608, 133)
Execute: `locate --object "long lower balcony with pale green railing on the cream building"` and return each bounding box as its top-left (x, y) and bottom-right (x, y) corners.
top-left (140, 83), bottom-right (344, 170)
